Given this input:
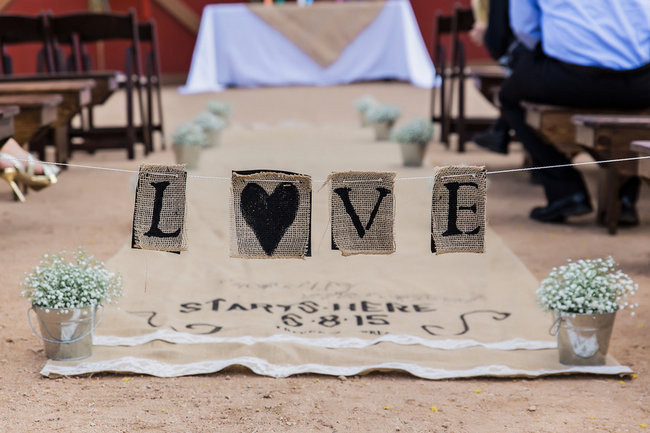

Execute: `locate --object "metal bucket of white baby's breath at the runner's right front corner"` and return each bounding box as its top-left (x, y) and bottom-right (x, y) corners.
top-left (537, 257), bottom-right (638, 365)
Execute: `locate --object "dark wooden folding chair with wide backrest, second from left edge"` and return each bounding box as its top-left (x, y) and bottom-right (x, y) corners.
top-left (49, 9), bottom-right (152, 159)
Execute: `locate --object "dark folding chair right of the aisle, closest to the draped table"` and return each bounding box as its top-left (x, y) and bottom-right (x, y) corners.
top-left (431, 11), bottom-right (453, 147)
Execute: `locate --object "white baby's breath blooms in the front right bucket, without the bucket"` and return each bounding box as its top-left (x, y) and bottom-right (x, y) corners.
top-left (537, 257), bottom-right (638, 315)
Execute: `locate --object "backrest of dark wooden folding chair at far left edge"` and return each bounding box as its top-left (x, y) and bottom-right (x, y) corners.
top-left (0, 14), bottom-right (54, 75)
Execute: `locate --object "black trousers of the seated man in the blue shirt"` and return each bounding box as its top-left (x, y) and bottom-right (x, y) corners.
top-left (499, 48), bottom-right (650, 202)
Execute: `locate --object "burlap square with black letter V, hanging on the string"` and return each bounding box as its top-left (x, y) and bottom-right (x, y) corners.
top-left (330, 172), bottom-right (395, 256)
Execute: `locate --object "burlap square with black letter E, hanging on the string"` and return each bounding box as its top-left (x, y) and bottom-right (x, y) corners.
top-left (431, 166), bottom-right (486, 254)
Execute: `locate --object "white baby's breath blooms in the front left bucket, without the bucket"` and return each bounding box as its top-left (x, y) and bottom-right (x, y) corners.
top-left (21, 248), bottom-right (122, 312)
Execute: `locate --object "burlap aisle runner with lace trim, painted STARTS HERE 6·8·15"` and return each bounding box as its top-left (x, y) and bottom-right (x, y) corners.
top-left (43, 127), bottom-right (630, 378)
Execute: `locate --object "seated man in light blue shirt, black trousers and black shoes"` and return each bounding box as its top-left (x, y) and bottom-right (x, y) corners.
top-left (499, 0), bottom-right (650, 225)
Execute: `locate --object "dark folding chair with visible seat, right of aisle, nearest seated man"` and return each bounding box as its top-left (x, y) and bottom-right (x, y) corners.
top-left (443, 5), bottom-right (495, 152)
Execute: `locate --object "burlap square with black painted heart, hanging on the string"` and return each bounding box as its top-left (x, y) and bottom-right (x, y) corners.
top-left (230, 170), bottom-right (311, 259)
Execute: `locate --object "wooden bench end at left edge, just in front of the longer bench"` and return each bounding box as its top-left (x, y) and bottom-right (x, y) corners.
top-left (0, 94), bottom-right (63, 150)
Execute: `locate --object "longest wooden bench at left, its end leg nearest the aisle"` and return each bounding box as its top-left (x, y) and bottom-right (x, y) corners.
top-left (0, 79), bottom-right (95, 163)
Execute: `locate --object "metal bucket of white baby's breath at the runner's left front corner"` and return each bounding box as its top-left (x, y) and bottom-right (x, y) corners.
top-left (21, 248), bottom-right (122, 360)
